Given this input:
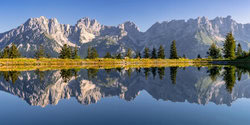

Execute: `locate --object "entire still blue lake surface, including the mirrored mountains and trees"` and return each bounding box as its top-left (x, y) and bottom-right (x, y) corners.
top-left (0, 66), bottom-right (250, 125)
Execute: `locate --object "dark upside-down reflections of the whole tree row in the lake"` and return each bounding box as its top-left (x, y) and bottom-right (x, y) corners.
top-left (0, 66), bottom-right (250, 93)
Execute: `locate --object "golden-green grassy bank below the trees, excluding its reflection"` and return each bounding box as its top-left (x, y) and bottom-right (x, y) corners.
top-left (0, 58), bottom-right (214, 66)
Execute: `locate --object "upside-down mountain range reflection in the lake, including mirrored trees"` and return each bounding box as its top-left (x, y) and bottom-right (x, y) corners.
top-left (0, 66), bottom-right (250, 107)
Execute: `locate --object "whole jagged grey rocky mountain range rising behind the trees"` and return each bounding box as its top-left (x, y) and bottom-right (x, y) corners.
top-left (0, 16), bottom-right (250, 58)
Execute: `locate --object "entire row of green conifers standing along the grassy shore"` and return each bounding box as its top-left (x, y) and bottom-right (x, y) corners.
top-left (0, 32), bottom-right (249, 59)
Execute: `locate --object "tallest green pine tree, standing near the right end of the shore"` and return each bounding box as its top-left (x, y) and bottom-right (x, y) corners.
top-left (223, 32), bottom-right (236, 59)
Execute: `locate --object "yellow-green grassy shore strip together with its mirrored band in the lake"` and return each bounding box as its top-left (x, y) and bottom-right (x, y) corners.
top-left (0, 58), bottom-right (221, 71)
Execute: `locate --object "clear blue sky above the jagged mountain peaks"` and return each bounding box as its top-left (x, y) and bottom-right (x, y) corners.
top-left (0, 0), bottom-right (250, 32)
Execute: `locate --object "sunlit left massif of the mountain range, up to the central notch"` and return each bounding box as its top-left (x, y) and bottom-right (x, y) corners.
top-left (0, 16), bottom-right (142, 57)
